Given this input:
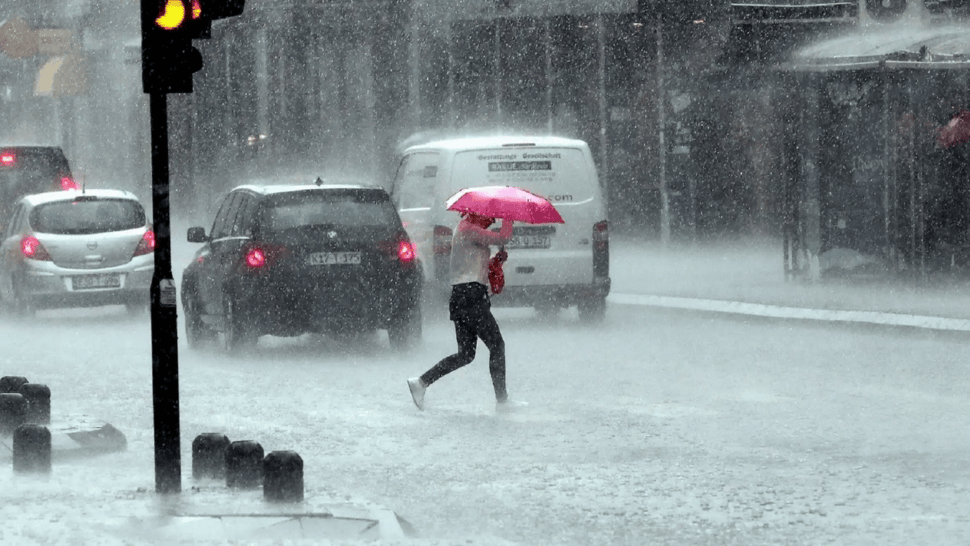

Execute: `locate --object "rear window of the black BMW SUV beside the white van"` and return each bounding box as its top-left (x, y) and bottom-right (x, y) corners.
top-left (260, 190), bottom-right (401, 232)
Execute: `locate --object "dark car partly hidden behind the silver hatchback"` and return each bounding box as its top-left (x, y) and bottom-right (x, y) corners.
top-left (0, 146), bottom-right (80, 231)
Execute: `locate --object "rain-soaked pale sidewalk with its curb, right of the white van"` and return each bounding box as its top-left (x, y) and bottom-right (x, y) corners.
top-left (609, 236), bottom-right (970, 332)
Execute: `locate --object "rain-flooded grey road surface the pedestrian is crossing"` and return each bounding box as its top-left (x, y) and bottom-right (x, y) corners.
top-left (0, 305), bottom-right (970, 546)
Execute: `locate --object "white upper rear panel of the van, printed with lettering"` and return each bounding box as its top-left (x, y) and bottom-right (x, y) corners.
top-left (453, 148), bottom-right (593, 203)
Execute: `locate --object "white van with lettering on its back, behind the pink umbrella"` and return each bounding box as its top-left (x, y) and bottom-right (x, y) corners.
top-left (391, 136), bottom-right (610, 321)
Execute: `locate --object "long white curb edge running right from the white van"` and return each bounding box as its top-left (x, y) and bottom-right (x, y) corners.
top-left (607, 293), bottom-right (970, 332)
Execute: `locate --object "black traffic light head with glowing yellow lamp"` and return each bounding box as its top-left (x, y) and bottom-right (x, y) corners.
top-left (141, 0), bottom-right (245, 93)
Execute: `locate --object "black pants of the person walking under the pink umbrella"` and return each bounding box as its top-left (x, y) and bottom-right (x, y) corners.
top-left (421, 282), bottom-right (508, 402)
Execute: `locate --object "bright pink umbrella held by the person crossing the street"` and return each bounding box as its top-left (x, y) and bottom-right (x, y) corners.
top-left (445, 186), bottom-right (566, 224)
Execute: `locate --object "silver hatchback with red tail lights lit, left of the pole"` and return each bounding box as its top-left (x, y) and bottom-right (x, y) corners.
top-left (0, 190), bottom-right (155, 315)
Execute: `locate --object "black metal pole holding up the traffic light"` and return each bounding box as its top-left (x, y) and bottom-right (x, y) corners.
top-left (149, 92), bottom-right (182, 493)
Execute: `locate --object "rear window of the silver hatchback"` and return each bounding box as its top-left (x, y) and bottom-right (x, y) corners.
top-left (30, 199), bottom-right (146, 235)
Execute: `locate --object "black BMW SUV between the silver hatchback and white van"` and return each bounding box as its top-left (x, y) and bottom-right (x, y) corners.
top-left (182, 179), bottom-right (422, 351)
